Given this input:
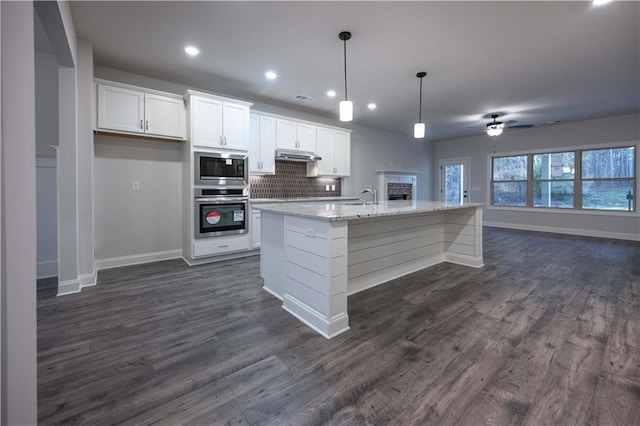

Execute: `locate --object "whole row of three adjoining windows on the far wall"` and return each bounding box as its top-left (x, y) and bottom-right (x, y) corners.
top-left (491, 146), bottom-right (637, 211)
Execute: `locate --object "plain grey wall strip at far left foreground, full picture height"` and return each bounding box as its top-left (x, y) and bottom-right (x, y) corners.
top-left (0, 1), bottom-right (38, 425)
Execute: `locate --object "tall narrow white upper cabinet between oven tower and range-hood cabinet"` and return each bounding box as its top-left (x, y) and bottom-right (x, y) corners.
top-left (249, 114), bottom-right (276, 174)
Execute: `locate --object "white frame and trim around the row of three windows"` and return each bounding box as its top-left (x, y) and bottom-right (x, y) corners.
top-left (486, 141), bottom-right (640, 217)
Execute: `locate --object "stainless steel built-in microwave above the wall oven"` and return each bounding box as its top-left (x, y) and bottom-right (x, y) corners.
top-left (193, 151), bottom-right (249, 185)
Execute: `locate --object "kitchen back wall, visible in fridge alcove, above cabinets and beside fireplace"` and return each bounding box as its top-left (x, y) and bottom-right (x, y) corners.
top-left (94, 65), bottom-right (433, 267)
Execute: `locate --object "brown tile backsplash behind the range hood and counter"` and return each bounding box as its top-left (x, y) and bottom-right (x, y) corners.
top-left (249, 160), bottom-right (342, 198)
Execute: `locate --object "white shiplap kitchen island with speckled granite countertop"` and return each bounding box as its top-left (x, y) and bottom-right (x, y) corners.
top-left (254, 200), bottom-right (483, 338)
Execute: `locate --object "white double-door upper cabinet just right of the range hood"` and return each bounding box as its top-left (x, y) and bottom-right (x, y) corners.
top-left (307, 126), bottom-right (351, 177)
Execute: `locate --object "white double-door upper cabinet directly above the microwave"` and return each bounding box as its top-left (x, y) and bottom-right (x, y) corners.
top-left (187, 90), bottom-right (251, 151)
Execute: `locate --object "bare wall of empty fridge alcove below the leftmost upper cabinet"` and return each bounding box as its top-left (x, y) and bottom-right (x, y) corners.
top-left (94, 135), bottom-right (183, 262)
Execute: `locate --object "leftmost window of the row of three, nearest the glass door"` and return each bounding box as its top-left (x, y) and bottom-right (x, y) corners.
top-left (491, 155), bottom-right (528, 206)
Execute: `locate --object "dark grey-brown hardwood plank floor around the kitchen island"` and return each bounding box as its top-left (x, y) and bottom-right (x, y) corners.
top-left (38, 228), bottom-right (640, 425)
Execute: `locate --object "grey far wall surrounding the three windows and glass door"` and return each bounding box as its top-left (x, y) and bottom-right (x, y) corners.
top-left (434, 114), bottom-right (640, 240)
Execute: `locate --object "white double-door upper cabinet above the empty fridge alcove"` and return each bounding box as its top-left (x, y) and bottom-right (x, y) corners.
top-left (96, 83), bottom-right (186, 139)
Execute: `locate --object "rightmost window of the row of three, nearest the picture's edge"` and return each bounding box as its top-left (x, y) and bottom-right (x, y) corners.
top-left (582, 146), bottom-right (635, 210)
